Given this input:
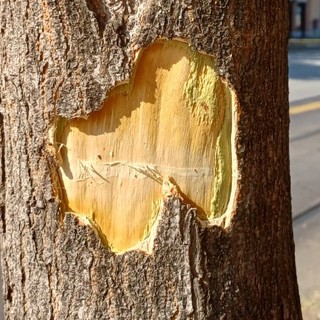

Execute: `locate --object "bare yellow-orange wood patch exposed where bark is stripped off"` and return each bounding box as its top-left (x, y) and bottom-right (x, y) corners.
top-left (53, 40), bottom-right (232, 252)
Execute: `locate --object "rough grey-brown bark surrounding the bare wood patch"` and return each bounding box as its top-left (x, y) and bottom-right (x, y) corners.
top-left (0, 0), bottom-right (301, 319)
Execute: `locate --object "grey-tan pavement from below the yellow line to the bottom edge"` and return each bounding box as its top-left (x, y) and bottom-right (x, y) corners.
top-left (290, 101), bottom-right (320, 320)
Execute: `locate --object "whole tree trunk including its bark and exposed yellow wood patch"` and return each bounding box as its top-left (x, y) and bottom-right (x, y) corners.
top-left (0, 0), bottom-right (301, 319)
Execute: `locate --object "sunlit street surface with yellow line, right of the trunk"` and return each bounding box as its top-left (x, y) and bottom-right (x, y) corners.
top-left (289, 48), bottom-right (320, 320)
